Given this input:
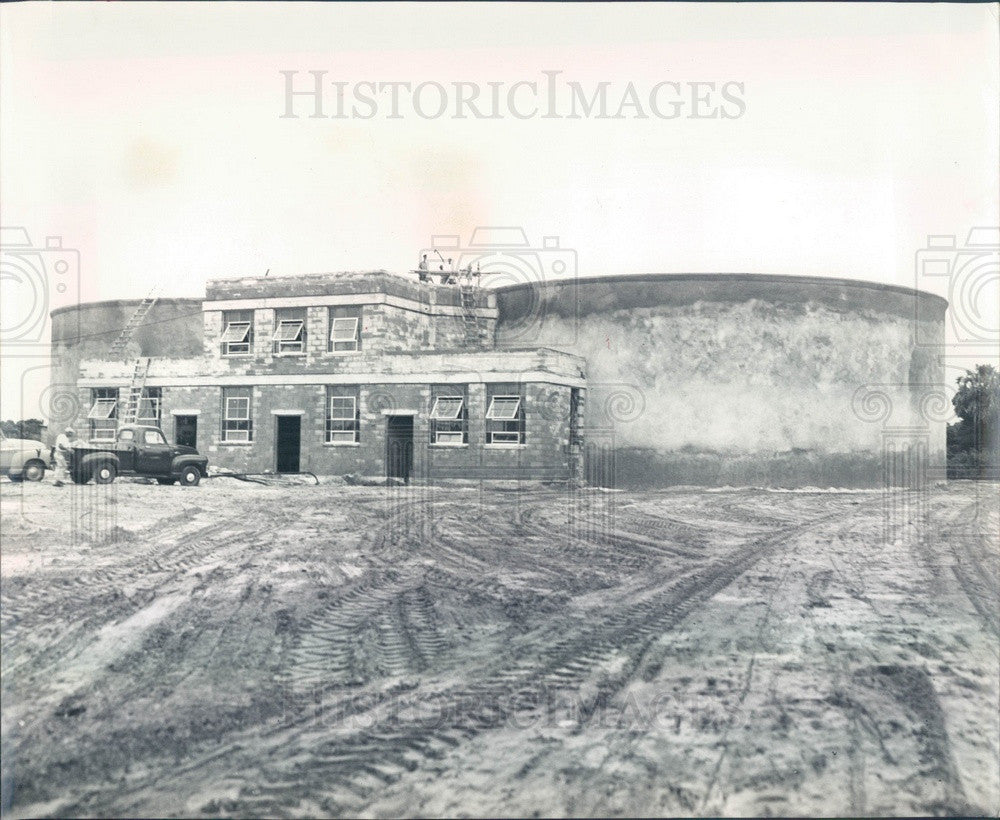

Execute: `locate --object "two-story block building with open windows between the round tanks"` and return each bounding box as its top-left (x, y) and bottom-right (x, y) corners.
top-left (62, 272), bottom-right (586, 480)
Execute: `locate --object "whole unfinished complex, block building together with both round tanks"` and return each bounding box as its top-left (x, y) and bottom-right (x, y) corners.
top-left (50, 271), bottom-right (947, 487)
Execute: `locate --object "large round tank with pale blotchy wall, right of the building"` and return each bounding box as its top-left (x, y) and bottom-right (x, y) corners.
top-left (497, 274), bottom-right (950, 487)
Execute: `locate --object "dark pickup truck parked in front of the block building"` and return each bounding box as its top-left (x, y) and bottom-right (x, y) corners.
top-left (68, 424), bottom-right (208, 487)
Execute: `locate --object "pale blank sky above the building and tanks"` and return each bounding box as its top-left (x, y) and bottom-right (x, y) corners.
top-left (0, 3), bottom-right (1000, 418)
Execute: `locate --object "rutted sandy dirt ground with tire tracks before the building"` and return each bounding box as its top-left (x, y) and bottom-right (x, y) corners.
top-left (0, 479), bottom-right (1000, 817)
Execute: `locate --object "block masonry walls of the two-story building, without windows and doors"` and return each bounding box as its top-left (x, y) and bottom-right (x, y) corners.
top-left (66, 272), bottom-right (585, 482)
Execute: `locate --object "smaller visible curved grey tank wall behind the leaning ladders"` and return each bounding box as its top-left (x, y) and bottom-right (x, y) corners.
top-left (44, 299), bottom-right (204, 414)
